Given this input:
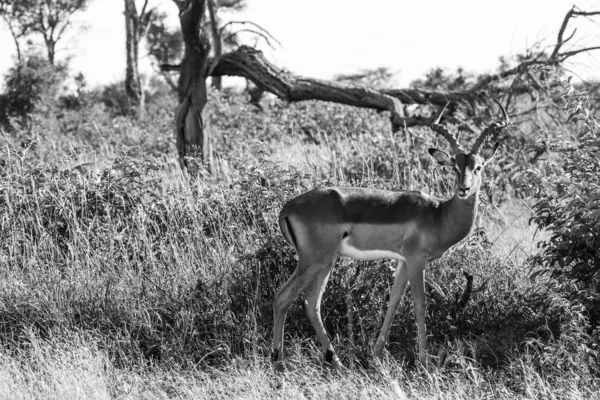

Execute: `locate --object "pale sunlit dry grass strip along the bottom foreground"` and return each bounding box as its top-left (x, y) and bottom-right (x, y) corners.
top-left (0, 335), bottom-right (598, 400)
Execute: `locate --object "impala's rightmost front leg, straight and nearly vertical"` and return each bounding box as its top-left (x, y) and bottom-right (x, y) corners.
top-left (406, 257), bottom-right (427, 363)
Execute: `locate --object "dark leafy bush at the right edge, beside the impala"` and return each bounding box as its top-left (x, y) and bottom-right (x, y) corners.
top-left (518, 73), bottom-right (600, 326)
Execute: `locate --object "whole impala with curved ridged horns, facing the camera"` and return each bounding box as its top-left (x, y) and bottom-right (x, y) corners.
top-left (273, 99), bottom-right (508, 370)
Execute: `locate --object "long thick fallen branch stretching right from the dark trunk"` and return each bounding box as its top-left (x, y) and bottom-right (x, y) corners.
top-left (161, 8), bottom-right (600, 131)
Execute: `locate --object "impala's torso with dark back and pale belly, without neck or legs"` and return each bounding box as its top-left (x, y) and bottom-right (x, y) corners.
top-left (279, 187), bottom-right (440, 260)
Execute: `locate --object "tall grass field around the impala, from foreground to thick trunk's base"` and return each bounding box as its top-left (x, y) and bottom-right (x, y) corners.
top-left (0, 86), bottom-right (600, 398)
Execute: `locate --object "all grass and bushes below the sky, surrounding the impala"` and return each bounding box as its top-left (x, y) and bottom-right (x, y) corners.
top-left (0, 1), bottom-right (600, 399)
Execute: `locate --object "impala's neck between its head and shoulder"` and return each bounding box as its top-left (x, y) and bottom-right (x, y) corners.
top-left (441, 186), bottom-right (479, 248)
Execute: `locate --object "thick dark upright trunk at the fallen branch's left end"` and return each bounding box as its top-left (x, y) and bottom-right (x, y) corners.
top-left (175, 0), bottom-right (212, 172)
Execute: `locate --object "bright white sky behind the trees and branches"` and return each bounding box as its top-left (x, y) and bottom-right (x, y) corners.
top-left (0, 0), bottom-right (600, 87)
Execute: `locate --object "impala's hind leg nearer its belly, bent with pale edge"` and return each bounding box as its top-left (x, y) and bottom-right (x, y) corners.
top-left (304, 255), bottom-right (341, 367)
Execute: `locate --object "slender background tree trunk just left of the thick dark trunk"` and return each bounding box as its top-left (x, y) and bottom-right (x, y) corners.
top-left (125, 0), bottom-right (144, 118)
